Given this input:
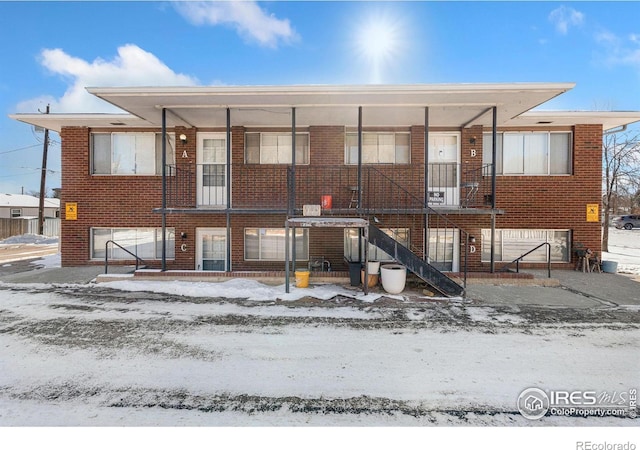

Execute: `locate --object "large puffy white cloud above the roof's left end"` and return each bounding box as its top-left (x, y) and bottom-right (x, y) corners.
top-left (17, 44), bottom-right (198, 113)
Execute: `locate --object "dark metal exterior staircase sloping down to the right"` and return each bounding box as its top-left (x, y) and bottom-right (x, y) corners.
top-left (369, 225), bottom-right (464, 297)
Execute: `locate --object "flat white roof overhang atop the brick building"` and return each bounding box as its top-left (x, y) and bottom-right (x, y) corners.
top-left (10, 83), bottom-right (640, 132)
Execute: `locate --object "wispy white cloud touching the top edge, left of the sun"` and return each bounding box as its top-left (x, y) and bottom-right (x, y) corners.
top-left (175, 1), bottom-right (297, 48)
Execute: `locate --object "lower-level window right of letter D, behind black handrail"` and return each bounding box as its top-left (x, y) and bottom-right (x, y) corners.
top-left (482, 229), bottom-right (570, 262)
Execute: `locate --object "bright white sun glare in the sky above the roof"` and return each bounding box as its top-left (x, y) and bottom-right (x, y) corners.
top-left (356, 15), bottom-right (402, 83)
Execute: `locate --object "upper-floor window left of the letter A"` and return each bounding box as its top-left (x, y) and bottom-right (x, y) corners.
top-left (91, 133), bottom-right (176, 175)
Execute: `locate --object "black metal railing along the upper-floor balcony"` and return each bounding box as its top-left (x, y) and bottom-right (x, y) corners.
top-left (166, 163), bottom-right (491, 214)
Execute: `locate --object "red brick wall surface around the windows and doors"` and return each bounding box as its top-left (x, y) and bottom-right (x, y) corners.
top-left (61, 121), bottom-right (602, 270)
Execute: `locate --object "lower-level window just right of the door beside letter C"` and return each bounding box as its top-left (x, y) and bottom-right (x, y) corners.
top-left (244, 228), bottom-right (309, 261)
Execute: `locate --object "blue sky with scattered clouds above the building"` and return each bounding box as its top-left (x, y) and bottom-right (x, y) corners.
top-left (0, 0), bottom-right (640, 193)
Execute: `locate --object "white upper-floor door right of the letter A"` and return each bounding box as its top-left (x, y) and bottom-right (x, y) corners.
top-left (196, 133), bottom-right (229, 207)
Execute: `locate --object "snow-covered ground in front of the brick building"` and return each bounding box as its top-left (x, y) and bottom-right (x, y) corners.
top-left (0, 230), bottom-right (640, 449)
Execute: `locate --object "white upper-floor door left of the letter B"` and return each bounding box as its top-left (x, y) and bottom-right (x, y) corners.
top-left (428, 133), bottom-right (460, 207)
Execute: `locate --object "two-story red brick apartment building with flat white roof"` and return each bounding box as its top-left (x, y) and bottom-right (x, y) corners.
top-left (12, 83), bottom-right (640, 296)
